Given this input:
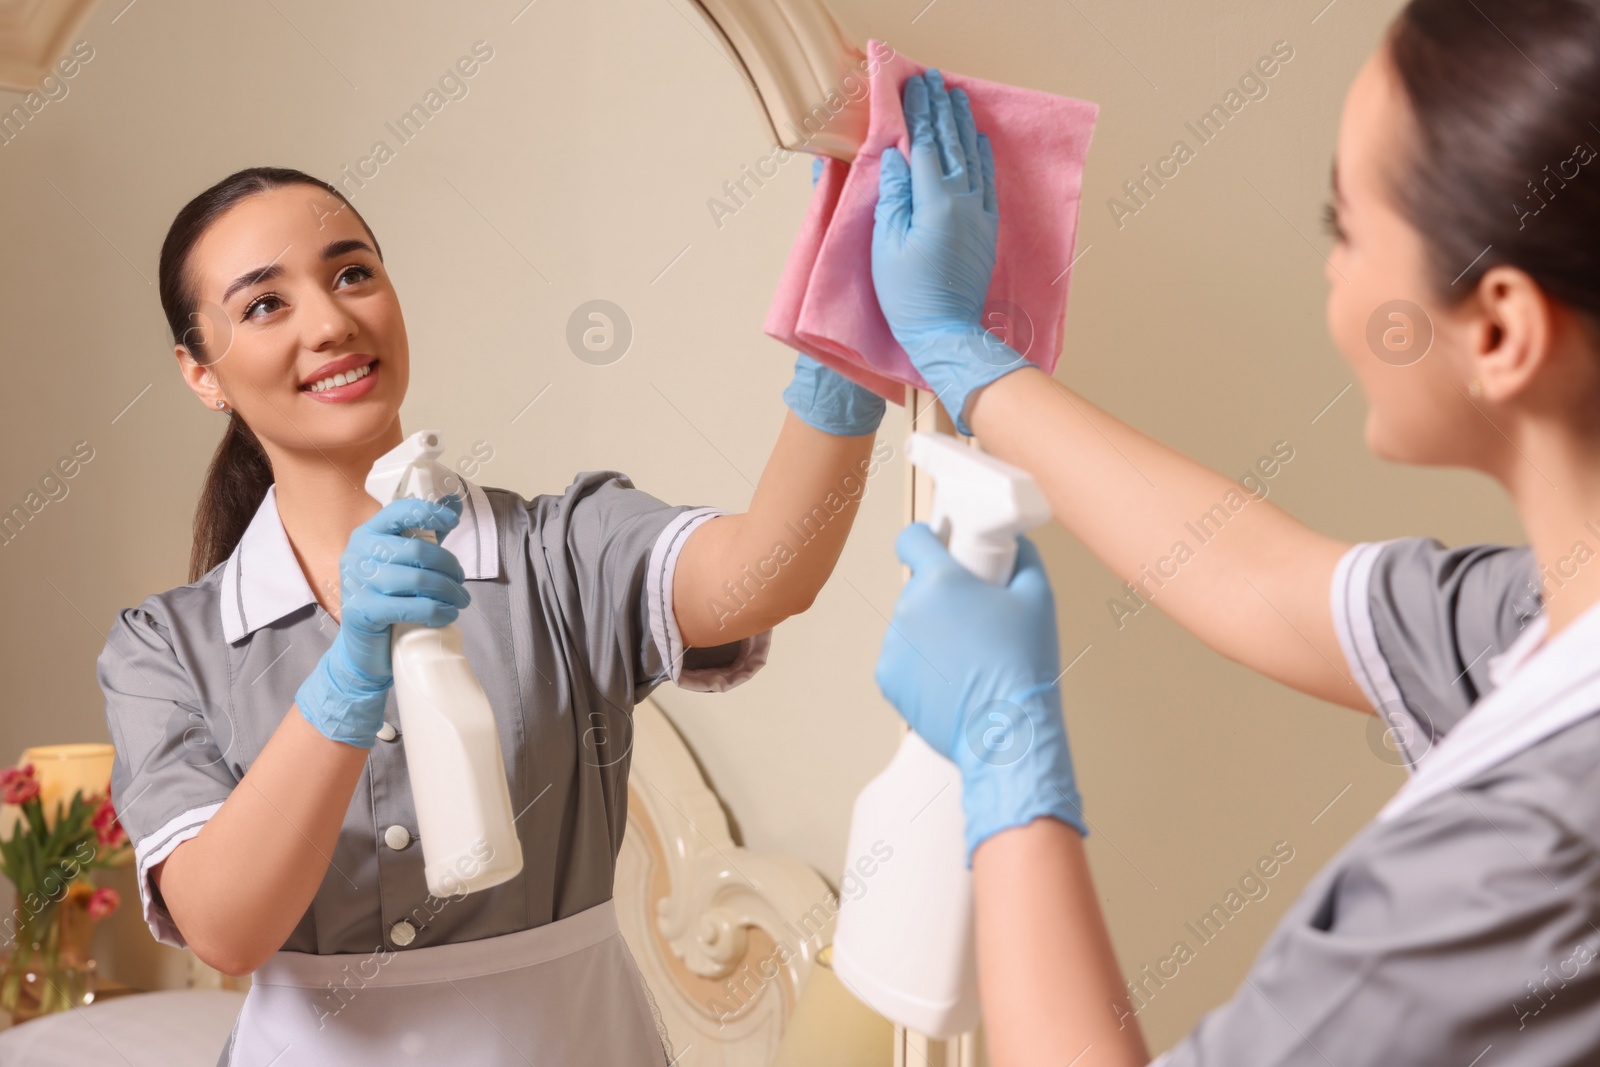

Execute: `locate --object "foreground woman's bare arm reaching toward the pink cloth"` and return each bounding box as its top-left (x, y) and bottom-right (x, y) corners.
top-left (966, 368), bottom-right (1370, 710)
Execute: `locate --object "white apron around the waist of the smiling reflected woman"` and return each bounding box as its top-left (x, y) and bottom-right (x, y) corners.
top-left (219, 901), bottom-right (666, 1067)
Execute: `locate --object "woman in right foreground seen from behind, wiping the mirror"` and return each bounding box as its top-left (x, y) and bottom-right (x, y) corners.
top-left (874, 0), bottom-right (1600, 1067)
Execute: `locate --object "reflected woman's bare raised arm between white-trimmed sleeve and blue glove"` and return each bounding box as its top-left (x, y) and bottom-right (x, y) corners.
top-left (672, 411), bottom-right (875, 648)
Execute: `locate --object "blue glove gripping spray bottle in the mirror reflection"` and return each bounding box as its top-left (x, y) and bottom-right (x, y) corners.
top-left (294, 493), bottom-right (472, 749)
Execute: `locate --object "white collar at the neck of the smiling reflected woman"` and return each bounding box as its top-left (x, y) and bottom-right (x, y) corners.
top-left (221, 478), bottom-right (499, 645)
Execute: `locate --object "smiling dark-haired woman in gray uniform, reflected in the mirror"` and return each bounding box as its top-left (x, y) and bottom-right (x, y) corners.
top-left (99, 168), bottom-right (883, 1067)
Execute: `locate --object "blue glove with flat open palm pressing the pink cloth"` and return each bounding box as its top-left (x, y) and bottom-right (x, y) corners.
top-left (872, 67), bottom-right (1027, 434)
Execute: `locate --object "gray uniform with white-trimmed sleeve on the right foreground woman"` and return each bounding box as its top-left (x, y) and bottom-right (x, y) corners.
top-left (1157, 537), bottom-right (1600, 1067)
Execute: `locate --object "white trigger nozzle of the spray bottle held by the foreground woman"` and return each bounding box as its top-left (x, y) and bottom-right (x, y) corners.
top-left (906, 434), bottom-right (1050, 585)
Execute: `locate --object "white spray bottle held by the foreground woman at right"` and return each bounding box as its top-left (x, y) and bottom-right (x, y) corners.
top-left (834, 434), bottom-right (1050, 1038)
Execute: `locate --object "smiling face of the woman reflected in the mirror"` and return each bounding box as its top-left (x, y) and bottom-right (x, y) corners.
top-left (178, 184), bottom-right (410, 456)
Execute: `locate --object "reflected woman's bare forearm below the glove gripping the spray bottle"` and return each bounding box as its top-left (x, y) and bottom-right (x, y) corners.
top-left (154, 707), bottom-right (368, 976)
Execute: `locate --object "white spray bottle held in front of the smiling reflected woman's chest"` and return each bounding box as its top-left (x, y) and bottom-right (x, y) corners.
top-left (366, 430), bottom-right (522, 897)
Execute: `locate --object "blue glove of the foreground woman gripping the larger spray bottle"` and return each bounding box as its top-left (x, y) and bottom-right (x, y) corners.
top-left (877, 523), bottom-right (1088, 867)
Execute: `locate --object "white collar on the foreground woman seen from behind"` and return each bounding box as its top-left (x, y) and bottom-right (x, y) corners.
top-left (1378, 603), bottom-right (1600, 822)
